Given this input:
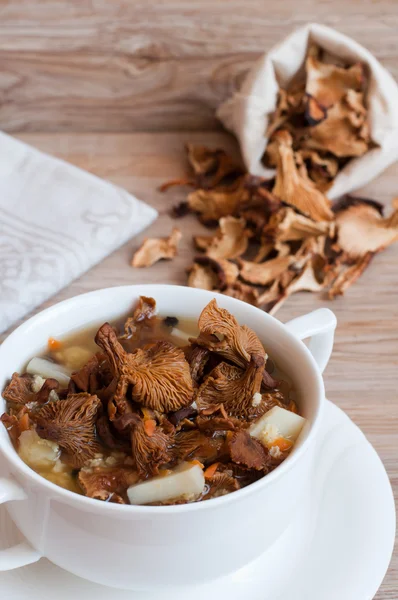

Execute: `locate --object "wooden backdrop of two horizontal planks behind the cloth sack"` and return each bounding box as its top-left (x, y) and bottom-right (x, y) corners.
top-left (0, 0), bottom-right (398, 132)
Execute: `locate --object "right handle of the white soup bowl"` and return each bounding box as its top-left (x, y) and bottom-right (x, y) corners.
top-left (285, 308), bottom-right (337, 373)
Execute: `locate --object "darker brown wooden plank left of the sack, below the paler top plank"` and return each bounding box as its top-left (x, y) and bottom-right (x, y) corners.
top-left (0, 51), bottom-right (253, 132)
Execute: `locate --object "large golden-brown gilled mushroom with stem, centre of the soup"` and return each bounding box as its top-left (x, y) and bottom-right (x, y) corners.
top-left (95, 323), bottom-right (193, 412)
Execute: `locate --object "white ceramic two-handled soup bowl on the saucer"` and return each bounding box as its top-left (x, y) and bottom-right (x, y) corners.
top-left (0, 285), bottom-right (336, 589)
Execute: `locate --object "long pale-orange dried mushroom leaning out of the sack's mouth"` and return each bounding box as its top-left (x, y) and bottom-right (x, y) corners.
top-left (272, 131), bottom-right (333, 221)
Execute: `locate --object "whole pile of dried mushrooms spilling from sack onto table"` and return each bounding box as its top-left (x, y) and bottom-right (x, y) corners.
top-left (132, 47), bottom-right (398, 313)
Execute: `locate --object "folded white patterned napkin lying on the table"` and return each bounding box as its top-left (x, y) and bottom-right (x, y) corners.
top-left (0, 133), bottom-right (157, 332)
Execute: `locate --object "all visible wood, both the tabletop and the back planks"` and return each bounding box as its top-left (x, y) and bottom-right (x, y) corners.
top-left (0, 0), bottom-right (398, 600)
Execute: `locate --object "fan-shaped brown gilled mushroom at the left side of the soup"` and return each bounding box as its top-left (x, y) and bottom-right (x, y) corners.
top-left (34, 392), bottom-right (102, 467)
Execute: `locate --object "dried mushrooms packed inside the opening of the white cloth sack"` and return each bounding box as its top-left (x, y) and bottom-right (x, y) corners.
top-left (263, 45), bottom-right (373, 189)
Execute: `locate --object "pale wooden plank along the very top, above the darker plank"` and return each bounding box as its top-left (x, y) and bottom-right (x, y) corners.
top-left (0, 0), bottom-right (398, 59)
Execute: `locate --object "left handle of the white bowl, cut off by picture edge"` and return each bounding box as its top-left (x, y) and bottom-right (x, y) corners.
top-left (0, 477), bottom-right (41, 571)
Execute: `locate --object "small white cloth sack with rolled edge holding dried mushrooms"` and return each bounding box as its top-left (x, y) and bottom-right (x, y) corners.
top-left (217, 23), bottom-right (398, 199)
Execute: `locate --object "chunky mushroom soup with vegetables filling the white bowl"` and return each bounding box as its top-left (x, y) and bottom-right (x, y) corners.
top-left (1, 297), bottom-right (305, 505)
